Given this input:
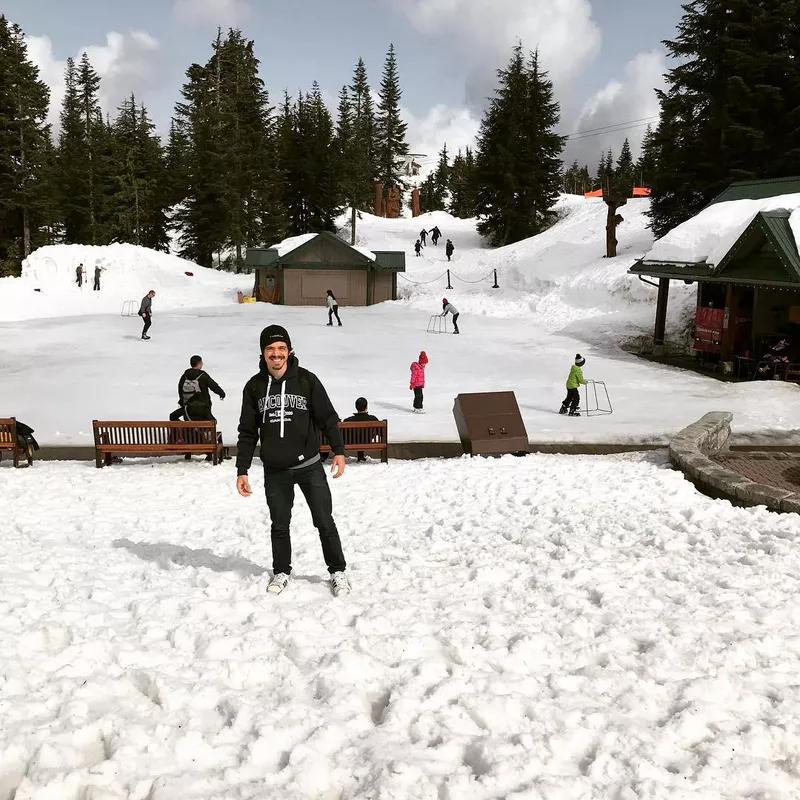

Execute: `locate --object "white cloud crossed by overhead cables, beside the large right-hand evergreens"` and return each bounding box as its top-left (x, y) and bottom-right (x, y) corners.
top-left (564, 50), bottom-right (667, 172)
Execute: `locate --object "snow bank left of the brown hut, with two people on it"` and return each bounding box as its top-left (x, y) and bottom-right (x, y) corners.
top-left (0, 244), bottom-right (253, 321)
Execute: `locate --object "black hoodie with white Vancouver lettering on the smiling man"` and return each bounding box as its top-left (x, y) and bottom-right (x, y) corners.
top-left (236, 356), bottom-right (344, 475)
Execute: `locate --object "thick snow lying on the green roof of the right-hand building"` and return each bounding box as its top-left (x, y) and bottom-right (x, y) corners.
top-left (644, 194), bottom-right (800, 266)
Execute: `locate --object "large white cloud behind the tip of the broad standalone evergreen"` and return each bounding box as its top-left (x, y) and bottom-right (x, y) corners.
top-left (388, 0), bottom-right (600, 107)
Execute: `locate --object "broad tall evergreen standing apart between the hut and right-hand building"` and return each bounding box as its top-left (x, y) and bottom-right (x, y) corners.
top-left (475, 45), bottom-right (564, 245)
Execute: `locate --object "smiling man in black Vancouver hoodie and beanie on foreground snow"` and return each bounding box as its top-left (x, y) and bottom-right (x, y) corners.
top-left (236, 325), bottom-right (350, 597)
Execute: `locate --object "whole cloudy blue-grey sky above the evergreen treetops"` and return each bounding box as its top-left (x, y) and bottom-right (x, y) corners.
top-left (2, 0), bottom-right (682, 170)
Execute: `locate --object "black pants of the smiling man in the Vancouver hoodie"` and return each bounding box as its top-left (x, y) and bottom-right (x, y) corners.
top-left (264, 462), bottom-right (347, 575)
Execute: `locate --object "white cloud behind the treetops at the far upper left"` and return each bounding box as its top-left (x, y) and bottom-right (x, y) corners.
top-left (25, 31), bottom-right (159, 129)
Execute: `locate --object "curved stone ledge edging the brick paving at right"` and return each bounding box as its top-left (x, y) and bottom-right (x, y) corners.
top-left (669, 411), bottom-right (800, 513)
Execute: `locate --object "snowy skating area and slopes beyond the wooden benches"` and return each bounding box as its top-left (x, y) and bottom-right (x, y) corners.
top-left (0, 197), bottom-right (800, 444)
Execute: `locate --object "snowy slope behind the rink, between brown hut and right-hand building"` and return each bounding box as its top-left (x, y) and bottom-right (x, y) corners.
top-left (348, 200), bottom-right (695, 340)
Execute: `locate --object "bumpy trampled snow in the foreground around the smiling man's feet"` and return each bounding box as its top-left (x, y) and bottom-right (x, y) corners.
top-left (0, 454), bottom-right (800, 800)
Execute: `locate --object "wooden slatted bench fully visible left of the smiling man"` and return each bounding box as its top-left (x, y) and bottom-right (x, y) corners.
top-left (92, 420), bottom-right (223, 469)
